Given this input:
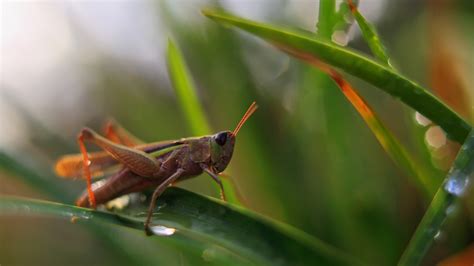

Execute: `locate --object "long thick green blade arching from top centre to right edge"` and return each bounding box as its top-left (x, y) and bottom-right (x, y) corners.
top-left (203, 11), bottom-right (471, 143)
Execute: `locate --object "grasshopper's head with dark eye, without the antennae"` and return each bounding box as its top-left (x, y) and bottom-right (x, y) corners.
top-left (210, 131), bottom-right (235, 173)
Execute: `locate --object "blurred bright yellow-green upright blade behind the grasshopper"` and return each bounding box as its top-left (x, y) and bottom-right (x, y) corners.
top-left (167, 40), bottom-right (241, 205)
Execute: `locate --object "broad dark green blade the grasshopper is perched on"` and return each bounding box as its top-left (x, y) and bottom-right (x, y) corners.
top-left (0, 188), bottom-right (360, 265)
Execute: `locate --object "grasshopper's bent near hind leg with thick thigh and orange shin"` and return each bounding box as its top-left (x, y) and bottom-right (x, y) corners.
top-left (77, 128), bottom-right (161, 208)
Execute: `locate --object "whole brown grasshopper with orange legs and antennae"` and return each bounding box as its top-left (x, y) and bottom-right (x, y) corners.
top-left (55, 102), bottom-right (258, 235)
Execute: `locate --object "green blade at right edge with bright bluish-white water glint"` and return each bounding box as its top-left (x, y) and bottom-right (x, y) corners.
top-left (399, 130), bottom-right (474, 265)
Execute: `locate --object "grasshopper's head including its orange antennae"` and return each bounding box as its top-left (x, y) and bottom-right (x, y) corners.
top-left (211, 102), bottom-right (257, 173)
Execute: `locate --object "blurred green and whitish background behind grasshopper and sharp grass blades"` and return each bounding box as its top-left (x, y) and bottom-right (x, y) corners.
top-left (0, 0), bottom-right (474, 265)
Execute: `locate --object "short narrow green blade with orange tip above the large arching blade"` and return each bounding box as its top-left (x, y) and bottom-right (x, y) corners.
top-left (347, 0), bottom-right (392, 67)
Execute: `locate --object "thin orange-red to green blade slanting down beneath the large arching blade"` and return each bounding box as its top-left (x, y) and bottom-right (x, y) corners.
top-left (277, 45), bottom-right (436, 199)
